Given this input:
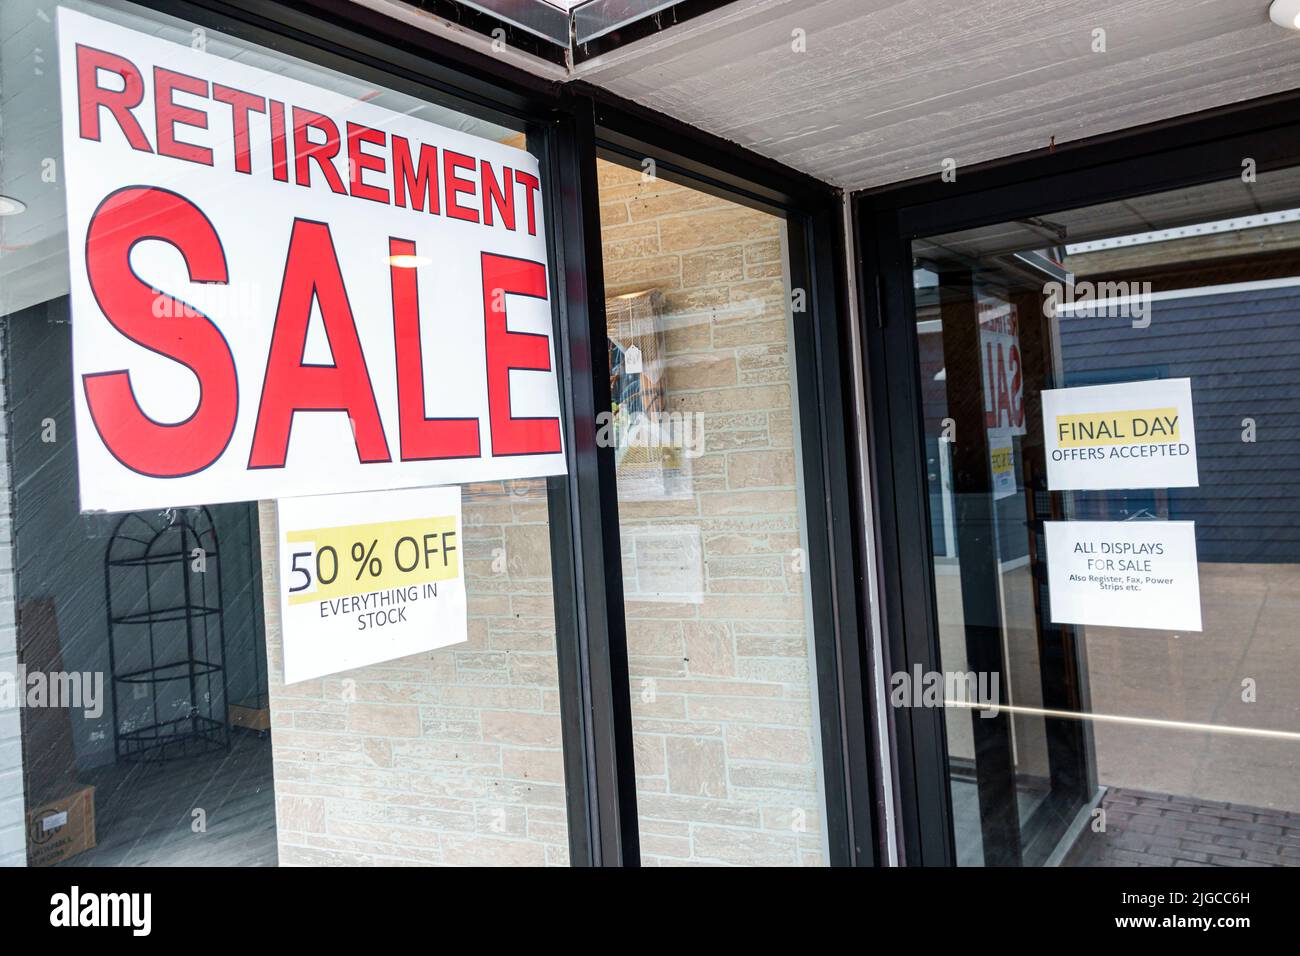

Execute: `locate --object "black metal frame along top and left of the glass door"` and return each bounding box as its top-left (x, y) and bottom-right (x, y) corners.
top-left (852, 91), bottom-right (1300, 865)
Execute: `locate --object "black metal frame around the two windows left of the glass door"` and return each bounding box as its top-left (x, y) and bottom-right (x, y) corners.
top-left (94, 0), bottom-right (884, 866)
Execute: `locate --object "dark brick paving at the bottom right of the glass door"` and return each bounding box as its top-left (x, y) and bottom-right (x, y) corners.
top-left (1065, 787), bottom-right (1300, 866)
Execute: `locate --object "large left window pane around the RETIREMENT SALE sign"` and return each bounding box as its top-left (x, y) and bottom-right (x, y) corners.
top-left (0, 0), bottom-right (568, 866)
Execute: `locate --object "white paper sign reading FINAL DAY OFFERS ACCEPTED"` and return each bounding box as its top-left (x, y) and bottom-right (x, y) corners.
top-left (1043, 378), bottom-right (1200, 492)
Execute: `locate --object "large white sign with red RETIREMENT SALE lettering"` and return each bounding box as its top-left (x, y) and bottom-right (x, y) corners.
top-left (59, 9), bottom-right (564, 511)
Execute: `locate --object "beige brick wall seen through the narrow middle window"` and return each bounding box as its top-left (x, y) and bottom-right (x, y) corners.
top-left (599, 161), bottom-right (826, 865)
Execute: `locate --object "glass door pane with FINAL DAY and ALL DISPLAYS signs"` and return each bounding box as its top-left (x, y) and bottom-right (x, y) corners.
top-left (909, 169), bottom-right (1300, 865)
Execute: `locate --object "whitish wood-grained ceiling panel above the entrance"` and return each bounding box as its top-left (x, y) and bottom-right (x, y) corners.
top-left (576, 0), bottom-right (1300, 189)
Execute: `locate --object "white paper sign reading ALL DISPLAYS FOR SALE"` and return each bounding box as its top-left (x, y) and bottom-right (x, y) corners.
top-left (1043, 522), bottom-right (1201, 631)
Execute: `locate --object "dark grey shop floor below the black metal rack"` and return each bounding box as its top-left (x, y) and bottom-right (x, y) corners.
top-left (65, 731), bottom-right (277, 866)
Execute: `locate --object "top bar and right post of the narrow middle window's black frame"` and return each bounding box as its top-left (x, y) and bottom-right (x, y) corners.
top-left (587, 85), bottom-right (883, 866)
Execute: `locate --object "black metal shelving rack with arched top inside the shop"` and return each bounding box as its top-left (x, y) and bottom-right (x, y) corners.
top-left (104, 507), bottom-right (230, 763)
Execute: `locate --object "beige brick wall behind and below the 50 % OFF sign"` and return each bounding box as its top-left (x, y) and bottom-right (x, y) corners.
top-left (261, 481), bottom-right (568, 866)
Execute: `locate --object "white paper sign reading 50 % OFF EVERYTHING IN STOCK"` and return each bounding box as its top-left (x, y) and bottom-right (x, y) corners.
top-left (276, 488), bottom-right (469, 684)
